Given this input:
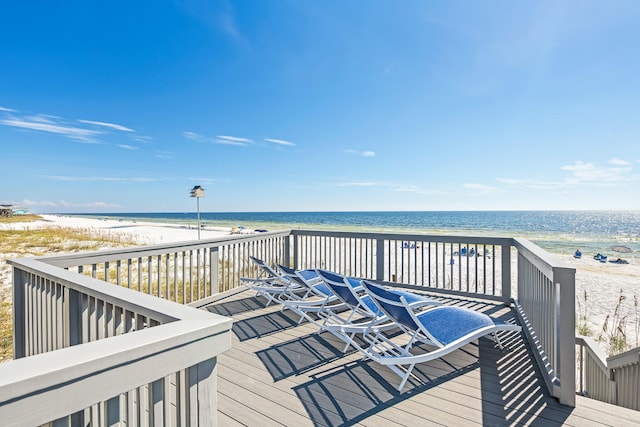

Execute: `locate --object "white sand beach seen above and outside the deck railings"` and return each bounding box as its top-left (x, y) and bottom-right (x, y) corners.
top-left (0, 215), bottom-right (640, 350)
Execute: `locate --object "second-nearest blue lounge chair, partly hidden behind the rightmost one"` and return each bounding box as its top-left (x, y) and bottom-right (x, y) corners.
top-left (316, 270), bottom-right (441, 352)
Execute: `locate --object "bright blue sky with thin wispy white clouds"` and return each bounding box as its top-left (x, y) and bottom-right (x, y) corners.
top-left (0, 0), bottom-right (640, 213)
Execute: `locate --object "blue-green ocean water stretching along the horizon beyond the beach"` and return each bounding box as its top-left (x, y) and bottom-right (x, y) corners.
top-left (72, 211), bottom-right (640, 262)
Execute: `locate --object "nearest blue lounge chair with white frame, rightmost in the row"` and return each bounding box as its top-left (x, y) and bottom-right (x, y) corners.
top-left (362, 280), bottom-right (521, 391)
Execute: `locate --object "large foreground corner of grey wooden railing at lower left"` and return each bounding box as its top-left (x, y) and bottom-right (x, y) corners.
top-left (0, 259), bottom-right (231, 426)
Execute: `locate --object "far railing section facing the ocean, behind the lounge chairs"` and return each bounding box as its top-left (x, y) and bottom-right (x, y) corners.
top-left (292, 230), bottom-right (512, 301)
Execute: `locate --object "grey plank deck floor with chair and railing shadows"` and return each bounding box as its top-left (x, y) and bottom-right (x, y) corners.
top-left (207, 292), bottom-right (640, 427)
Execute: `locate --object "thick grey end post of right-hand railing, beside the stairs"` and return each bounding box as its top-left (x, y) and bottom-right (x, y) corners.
top-left (553, 267), bottom-right (576, 406)
